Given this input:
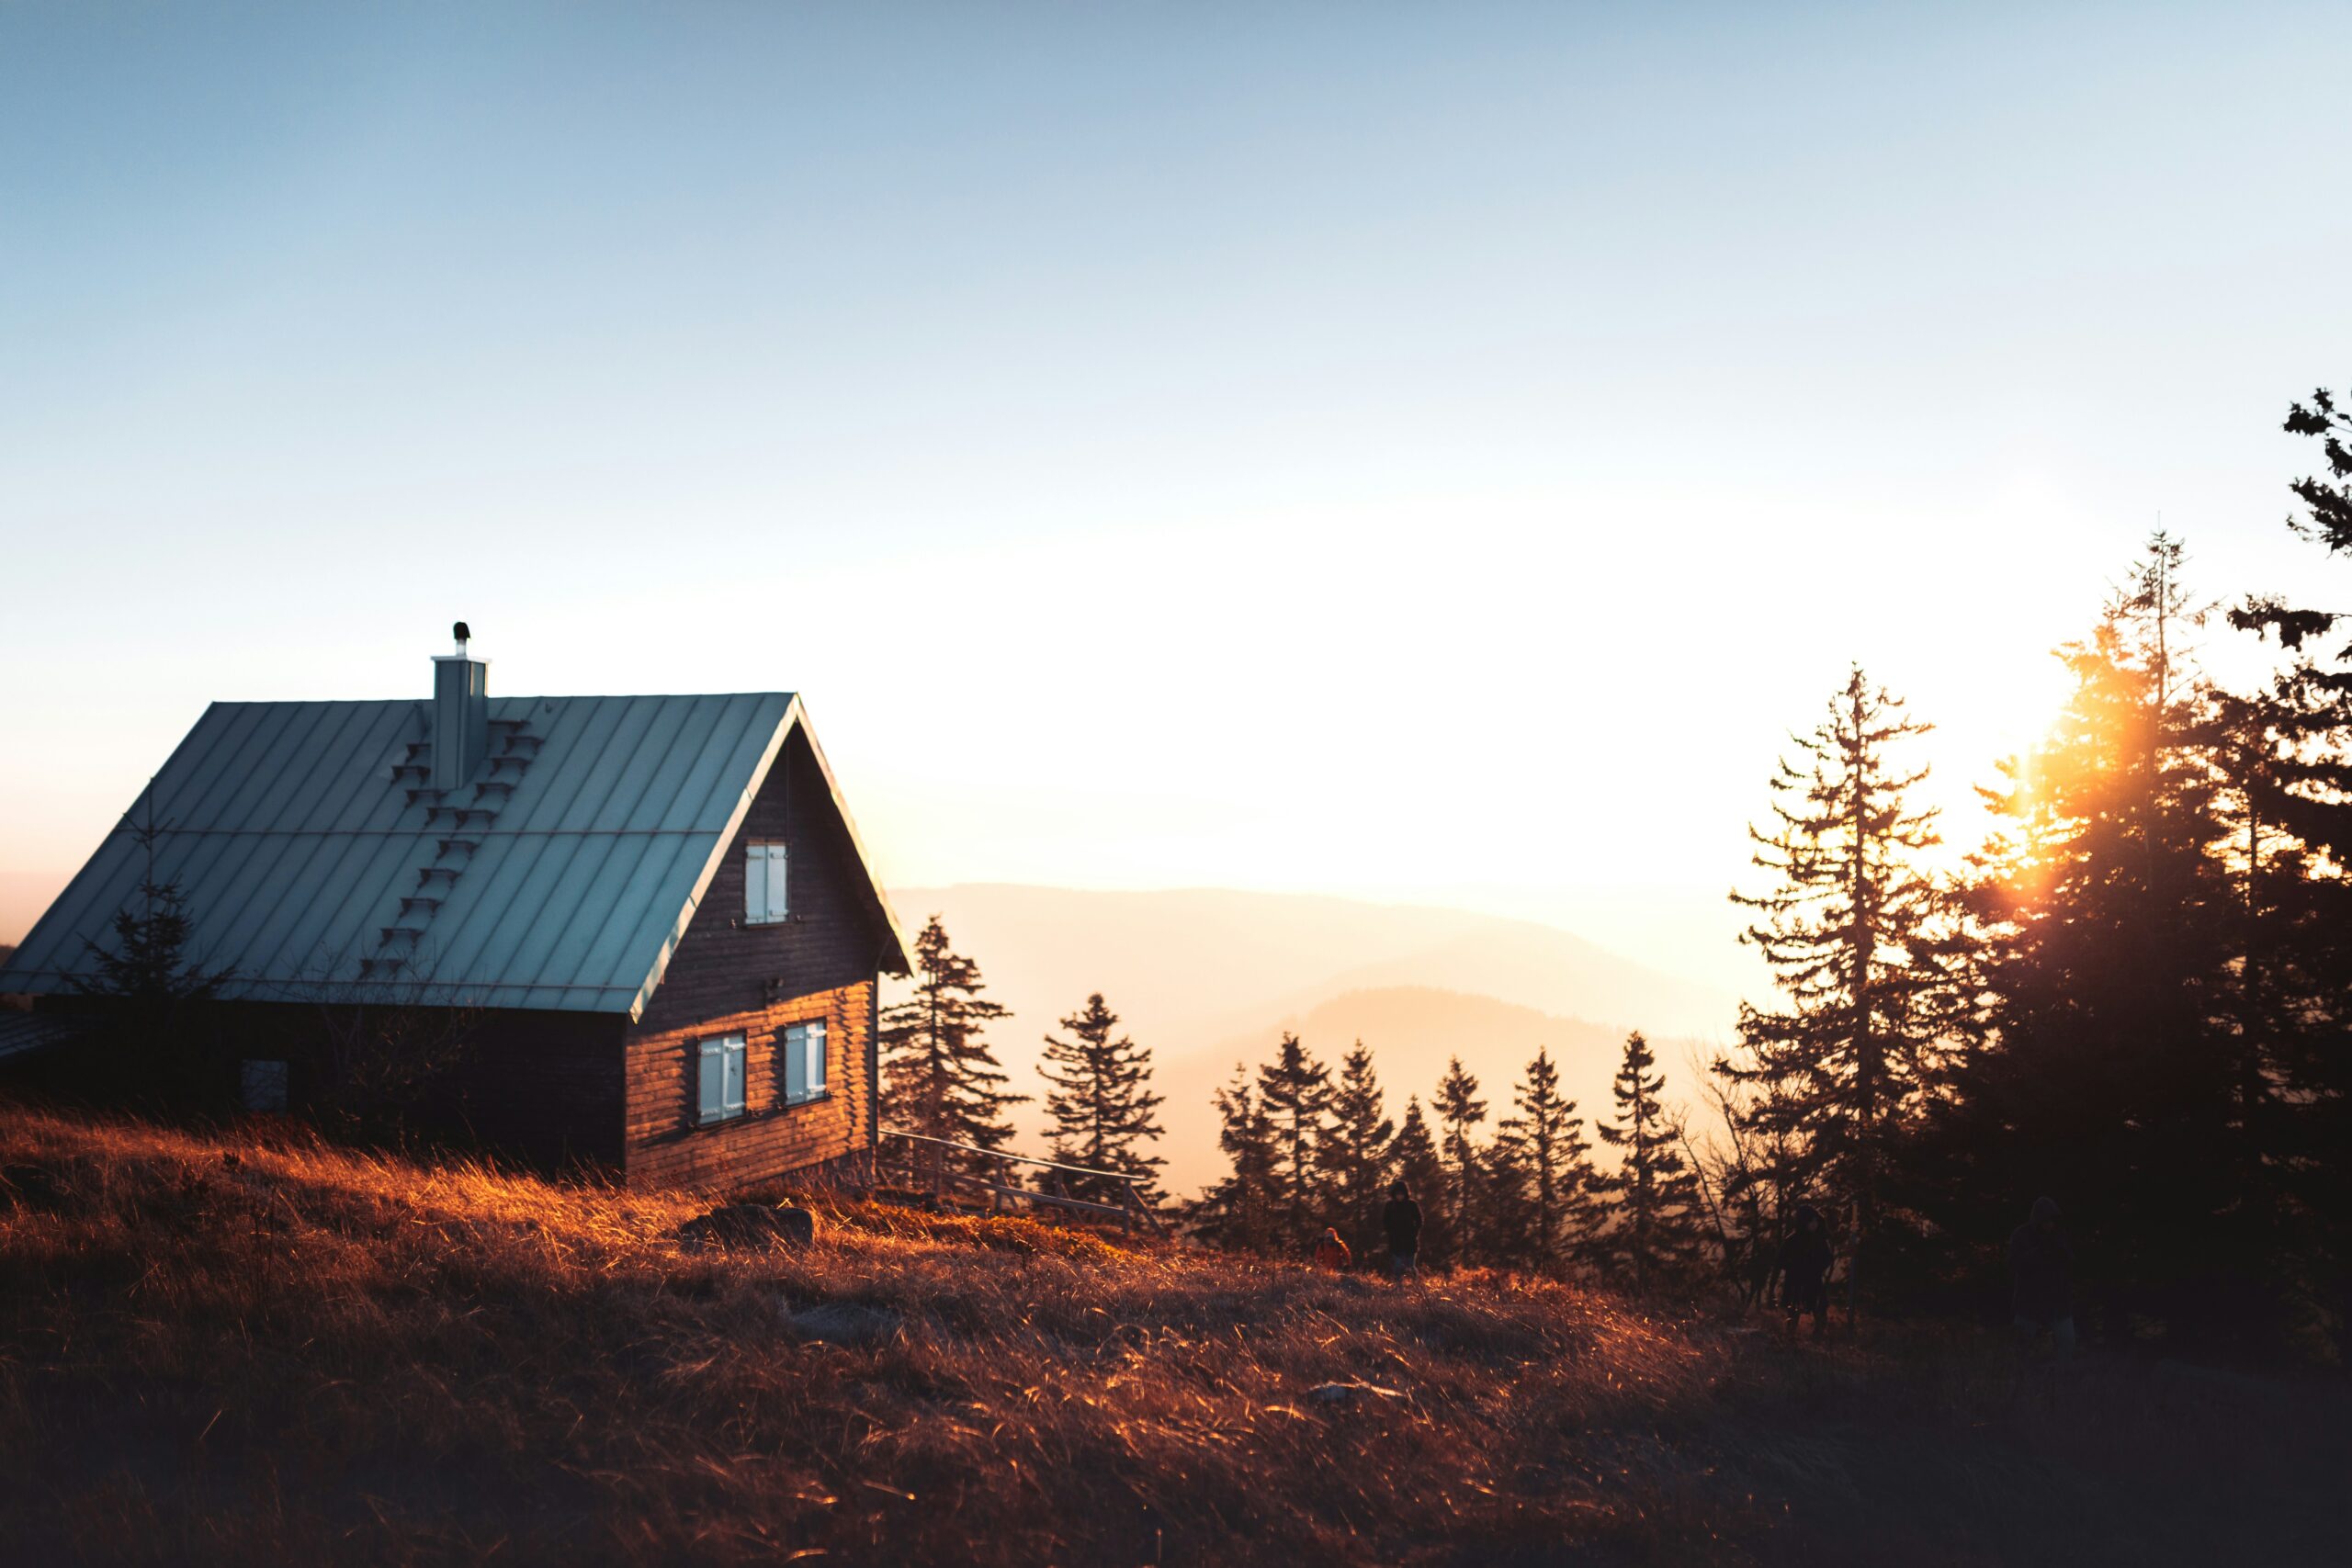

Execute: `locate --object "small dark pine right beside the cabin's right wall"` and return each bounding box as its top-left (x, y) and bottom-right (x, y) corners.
top-left (882, 915), bottom-right (1028, 1173)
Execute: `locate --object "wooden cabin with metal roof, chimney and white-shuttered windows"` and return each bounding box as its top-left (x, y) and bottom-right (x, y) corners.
top-left (0, 637), bottom-right (908, 1187)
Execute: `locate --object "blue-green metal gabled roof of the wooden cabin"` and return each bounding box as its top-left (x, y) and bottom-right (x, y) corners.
top-left (0, 691), bottom-right (906, 1018)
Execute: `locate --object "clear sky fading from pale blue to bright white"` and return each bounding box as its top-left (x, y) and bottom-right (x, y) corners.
top-left (0, 5), bottom-right (2352, 987)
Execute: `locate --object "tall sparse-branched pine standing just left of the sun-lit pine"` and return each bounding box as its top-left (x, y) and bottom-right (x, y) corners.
top-left (1717, 665), bottom-right (1957, 1324)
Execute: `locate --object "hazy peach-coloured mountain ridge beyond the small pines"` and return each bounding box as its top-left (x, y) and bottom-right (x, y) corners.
top-left (891, 884), bottom-right (1736, 1192)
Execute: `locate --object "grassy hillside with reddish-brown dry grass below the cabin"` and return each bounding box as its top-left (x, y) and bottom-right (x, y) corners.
top-left (0, 1105), bottom-right (2352, 1568)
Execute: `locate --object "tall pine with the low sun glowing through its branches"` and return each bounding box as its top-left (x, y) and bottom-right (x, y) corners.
top-left (1927, 534), bottom-right (2293, 1342)
